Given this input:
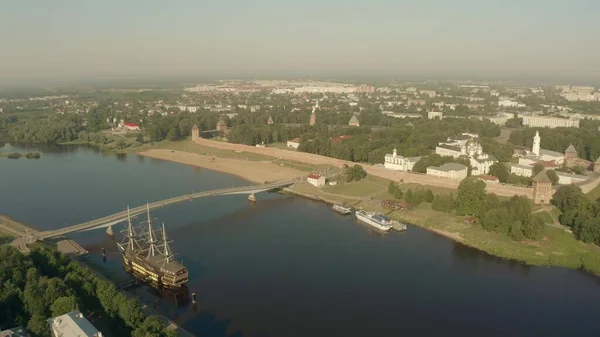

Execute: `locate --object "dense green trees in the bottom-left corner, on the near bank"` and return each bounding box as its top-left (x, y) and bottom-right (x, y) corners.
top-left (0, 246), bottom-right (177, 337)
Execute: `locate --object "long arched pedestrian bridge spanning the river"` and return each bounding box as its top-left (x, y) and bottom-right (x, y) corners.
top-left (33, 177), bottom-right (305, 240)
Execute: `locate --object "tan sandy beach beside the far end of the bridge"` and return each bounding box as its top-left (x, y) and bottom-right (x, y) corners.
top-left (138, 149), bottom-right (306, 184)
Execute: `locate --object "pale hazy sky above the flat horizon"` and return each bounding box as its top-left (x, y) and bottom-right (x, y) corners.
top-left (0, 0), bottom-right (600, 81)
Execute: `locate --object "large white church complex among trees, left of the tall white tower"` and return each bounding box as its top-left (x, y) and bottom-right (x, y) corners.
top-left (435, 133), bottom-right (498, 176)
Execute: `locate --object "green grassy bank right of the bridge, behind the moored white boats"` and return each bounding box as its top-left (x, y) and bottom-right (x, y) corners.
top-left (289, 177), bottom-right (600, 275)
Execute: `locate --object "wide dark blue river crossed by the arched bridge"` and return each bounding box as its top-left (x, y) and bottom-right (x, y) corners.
top-left (0, 145), bottom-right (600, 337)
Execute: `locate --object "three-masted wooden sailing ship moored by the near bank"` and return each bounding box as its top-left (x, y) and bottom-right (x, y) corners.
top-left (118, 207), bottom-right (188, 289)
